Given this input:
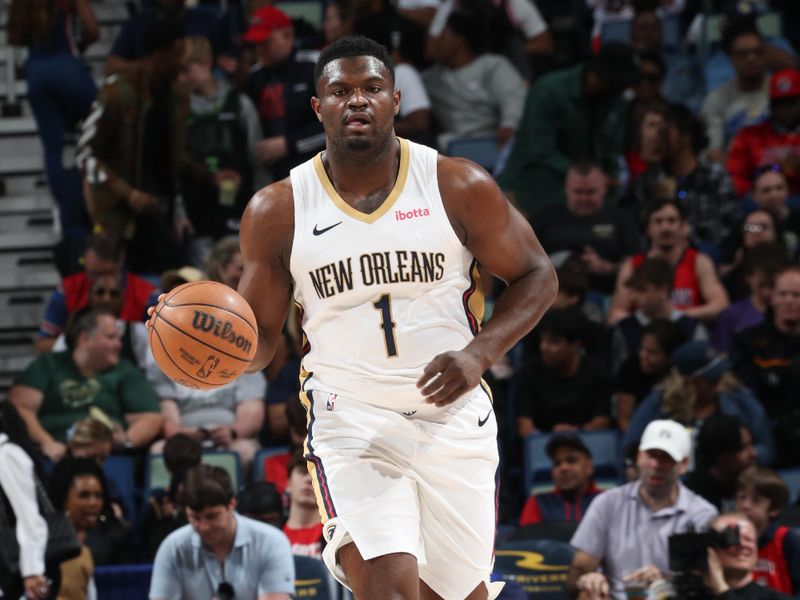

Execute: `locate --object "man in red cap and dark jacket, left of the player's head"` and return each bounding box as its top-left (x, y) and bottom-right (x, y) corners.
top-left (242, 6), bottom-right (325, 180)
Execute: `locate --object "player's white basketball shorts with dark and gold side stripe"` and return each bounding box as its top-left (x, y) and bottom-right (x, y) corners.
top-left (301, 386), bottom-right (498, 600)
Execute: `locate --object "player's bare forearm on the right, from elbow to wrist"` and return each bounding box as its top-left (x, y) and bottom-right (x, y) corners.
top-left (465, 256), bottom-right (558, 370)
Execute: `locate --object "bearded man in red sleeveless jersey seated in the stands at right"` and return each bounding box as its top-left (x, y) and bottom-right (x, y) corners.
top-left (608, 200), bottom-right (729, 325)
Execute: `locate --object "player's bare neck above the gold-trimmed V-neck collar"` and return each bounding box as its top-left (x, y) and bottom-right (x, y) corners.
top-left (322, 134), bottom-right (400, 206)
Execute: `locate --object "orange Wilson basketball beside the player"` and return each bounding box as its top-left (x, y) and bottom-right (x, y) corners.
top-left (150, 281), bottom-right (258, 390)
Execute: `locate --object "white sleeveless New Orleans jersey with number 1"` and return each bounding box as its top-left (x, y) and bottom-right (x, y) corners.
top-left (291, 139), bottom-right (483, 408)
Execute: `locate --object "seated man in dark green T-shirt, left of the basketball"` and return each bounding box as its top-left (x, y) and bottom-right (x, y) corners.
top-left (9, 308), bottom-right (162, 462)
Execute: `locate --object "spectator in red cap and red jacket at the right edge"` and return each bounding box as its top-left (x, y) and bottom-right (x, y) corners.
top-left (727, 69), bottom-right (800, 196)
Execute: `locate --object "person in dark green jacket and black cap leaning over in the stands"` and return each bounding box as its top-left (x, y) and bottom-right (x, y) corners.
top-left (498, 42), bottom-right (640, 214)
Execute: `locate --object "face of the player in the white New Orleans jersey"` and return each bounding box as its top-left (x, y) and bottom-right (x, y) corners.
top-left (311, 56), bottom-right (400, 152)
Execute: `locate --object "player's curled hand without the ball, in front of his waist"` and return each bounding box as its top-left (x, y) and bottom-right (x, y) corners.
top-left (417, 350), bottom-right (483, 406)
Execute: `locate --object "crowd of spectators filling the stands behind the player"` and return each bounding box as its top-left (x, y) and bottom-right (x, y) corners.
top-left (4, 0), bottom-right (800, 598)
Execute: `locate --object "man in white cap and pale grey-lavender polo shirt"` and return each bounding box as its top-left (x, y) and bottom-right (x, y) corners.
top-left (567, 420), bottom-right (717, 600)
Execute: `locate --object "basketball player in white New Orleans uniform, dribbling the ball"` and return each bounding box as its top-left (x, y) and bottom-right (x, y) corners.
top-left (239, 37), bottom-right (557, 600)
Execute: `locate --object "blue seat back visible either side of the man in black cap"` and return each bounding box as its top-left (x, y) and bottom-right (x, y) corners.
top-left (523, 429), bottom-right (623, 494)
